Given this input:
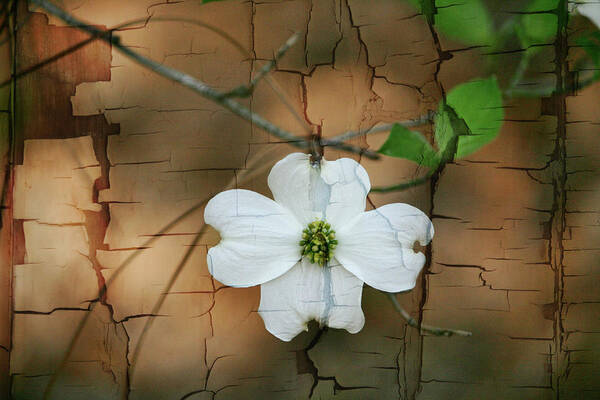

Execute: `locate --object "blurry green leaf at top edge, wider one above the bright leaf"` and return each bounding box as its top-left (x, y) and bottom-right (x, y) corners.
top-left (435, 0), bottom-right (494, 45)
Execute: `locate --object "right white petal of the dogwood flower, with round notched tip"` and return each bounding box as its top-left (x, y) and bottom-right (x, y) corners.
top-left (335, 203), bottom-right (433, 292)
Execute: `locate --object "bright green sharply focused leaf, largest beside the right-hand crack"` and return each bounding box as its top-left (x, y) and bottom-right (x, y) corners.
top-left (436, 76), bottom-right (504, 158)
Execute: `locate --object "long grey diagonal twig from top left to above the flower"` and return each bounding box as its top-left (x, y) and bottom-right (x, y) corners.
top-left (31, 0), bottom-right (379, 159)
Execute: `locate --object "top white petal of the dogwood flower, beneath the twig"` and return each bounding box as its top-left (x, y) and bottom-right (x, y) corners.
top-left (269, 153), bottom-right (371, 229)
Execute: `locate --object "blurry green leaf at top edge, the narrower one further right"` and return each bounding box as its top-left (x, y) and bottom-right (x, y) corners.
top-left (517, 0), bottom-right (559, 48)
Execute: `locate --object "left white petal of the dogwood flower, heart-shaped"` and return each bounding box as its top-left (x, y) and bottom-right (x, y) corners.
top-left (204, 189), bottom-right (302, 287)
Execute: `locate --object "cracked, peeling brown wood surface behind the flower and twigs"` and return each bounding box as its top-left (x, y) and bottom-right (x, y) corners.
top-left (0, 0), bottom-right (600, 400)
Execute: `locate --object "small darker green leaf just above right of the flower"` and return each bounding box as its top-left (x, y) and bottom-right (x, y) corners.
top-left (378, 124), bottom-right (439, 168)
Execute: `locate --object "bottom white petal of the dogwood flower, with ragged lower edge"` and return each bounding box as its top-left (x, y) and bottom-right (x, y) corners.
top-left (258, 259), bottom-right (365, 342)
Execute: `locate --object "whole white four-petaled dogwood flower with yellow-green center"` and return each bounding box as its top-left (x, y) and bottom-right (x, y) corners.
top-left (204, 153), bottom-right (433, 341)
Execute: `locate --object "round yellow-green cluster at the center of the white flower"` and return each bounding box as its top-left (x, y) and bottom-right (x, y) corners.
top-left (300, 220), bottom-right (337, 267)
